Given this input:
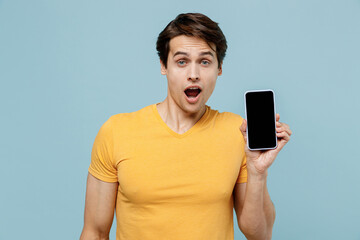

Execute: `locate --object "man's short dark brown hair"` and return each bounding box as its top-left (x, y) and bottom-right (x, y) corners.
top-left (156, 13), bottom-right (227, 68)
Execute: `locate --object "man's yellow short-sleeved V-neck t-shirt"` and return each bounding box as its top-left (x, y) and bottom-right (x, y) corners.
top-left (89, 104), bottom-right (247, 240)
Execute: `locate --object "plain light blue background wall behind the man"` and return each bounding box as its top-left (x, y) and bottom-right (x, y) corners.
top-left (0, 0), bottom-right (360, 240)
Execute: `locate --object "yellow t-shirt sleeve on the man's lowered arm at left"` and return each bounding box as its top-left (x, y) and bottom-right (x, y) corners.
top-left (89, 118), bottom-right (117, 182)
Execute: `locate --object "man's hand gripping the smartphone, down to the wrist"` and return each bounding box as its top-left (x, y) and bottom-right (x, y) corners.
top-left (240, 114), bottom-right (292, 176)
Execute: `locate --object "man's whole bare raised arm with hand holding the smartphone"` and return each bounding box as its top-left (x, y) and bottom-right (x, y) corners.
top-left (234, 114), bottom-right (292, 240)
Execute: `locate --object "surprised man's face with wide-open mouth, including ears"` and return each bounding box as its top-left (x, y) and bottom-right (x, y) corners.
top-left (161, 35), bottom-right (222, 114)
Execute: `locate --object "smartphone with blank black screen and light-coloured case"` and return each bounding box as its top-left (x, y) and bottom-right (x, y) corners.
top-left (244, 89), bottom-right (277, 150)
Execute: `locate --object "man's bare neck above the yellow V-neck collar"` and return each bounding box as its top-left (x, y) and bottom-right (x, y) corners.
top-left (157, 98), bottom-right (206, 134)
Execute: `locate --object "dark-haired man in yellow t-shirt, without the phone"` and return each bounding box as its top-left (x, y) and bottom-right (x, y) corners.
top-left (80, 14), bottom-right (291, 240)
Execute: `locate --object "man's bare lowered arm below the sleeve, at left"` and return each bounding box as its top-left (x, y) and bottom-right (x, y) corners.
top-left (80, 173), bottom-right (118, 240)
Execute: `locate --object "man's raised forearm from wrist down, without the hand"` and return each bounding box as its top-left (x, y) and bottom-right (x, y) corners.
top-left (239, 174), bottom-right (275, 240)
